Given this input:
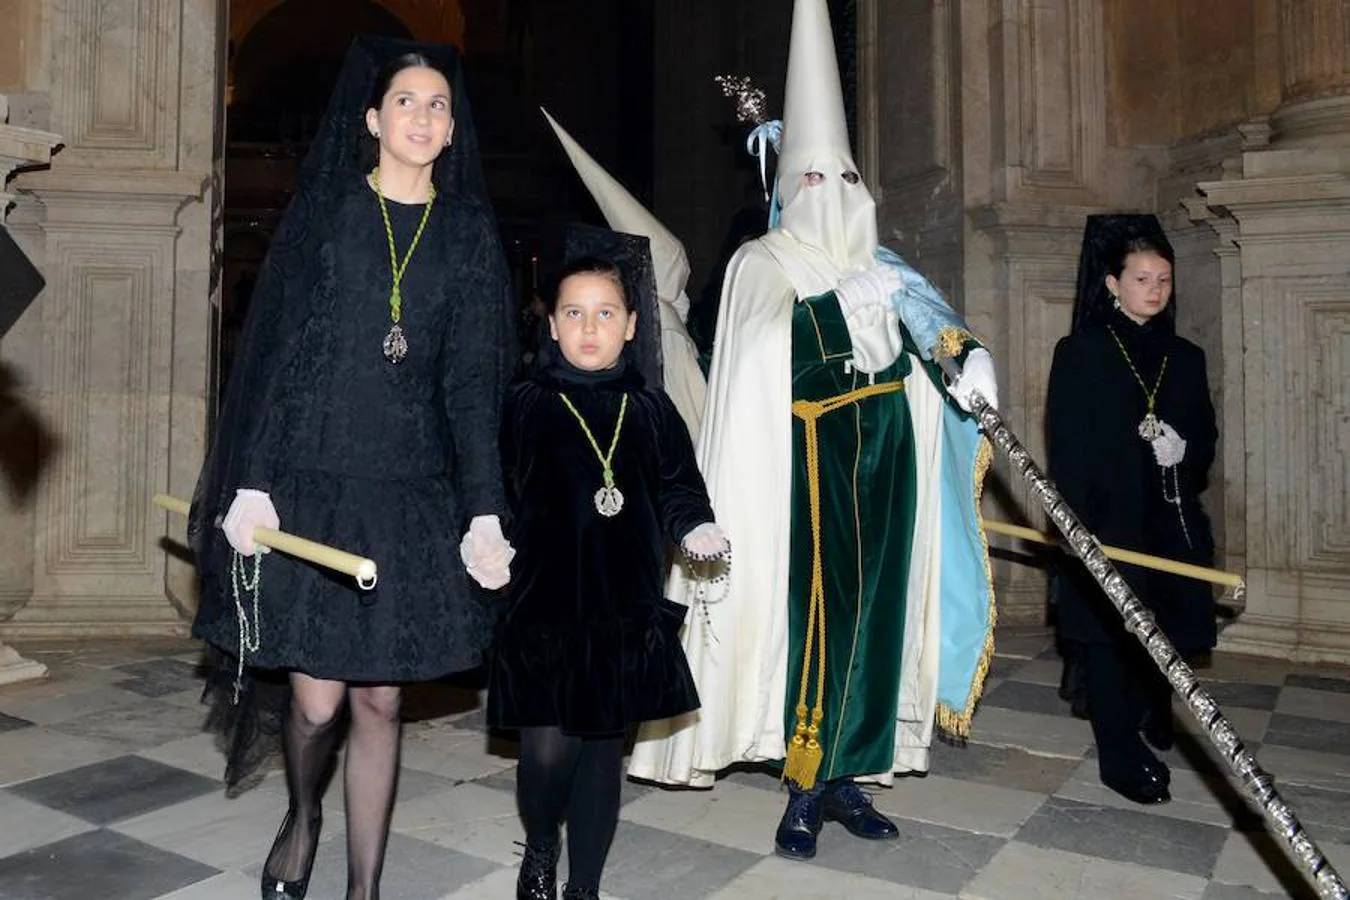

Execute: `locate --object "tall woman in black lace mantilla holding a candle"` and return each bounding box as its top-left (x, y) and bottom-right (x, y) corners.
top-left (189, 38), bottom-right (512, 900)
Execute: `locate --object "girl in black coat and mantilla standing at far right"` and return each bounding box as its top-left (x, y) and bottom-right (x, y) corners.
top-left (1046, 216), bottom-right (1218, 803)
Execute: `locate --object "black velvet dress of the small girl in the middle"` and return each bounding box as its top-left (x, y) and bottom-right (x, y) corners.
top-left (487, 363), bottom-right (713, 735)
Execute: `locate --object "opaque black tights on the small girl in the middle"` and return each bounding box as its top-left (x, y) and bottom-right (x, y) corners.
top-left (516, 727), bottom-right (624, 891)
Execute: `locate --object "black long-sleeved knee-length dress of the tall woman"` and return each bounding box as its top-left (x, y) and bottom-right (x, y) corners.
top-left (193, 178), bottom-right (509, 681)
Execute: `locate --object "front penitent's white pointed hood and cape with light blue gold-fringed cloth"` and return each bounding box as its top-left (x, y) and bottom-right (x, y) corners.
top-left (629, 0), bottom-right (994, 787)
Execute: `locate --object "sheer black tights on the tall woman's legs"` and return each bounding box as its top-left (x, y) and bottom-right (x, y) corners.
top-left (263, 673), bottom-right (401, 900)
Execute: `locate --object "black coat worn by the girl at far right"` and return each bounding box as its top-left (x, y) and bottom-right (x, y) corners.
top-left (1046, 312), bottom-right (1218, 652)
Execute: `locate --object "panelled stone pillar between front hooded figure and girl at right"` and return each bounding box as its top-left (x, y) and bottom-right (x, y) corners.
top-left (955, 0), bottom-right (1127, 623)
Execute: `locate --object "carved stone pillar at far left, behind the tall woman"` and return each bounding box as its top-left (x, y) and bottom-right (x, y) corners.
top-left (0, 0), bottom-right (224, 638)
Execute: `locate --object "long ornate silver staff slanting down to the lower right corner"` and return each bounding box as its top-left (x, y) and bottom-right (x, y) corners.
top-left (934, 354), bottom-right (1350, 900)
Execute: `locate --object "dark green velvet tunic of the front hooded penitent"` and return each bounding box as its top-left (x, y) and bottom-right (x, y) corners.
top-left (784, 291), bottom-right (917, 781)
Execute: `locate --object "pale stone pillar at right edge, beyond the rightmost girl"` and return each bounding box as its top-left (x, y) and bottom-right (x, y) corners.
top-left (1200, 0), bottom-right (1350, 663)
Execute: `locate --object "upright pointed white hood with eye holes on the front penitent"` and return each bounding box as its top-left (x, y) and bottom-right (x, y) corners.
top-left (778, 0), bottom-right (878, 274)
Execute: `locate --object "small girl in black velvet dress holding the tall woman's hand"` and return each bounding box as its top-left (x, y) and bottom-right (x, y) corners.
top-left (487, 258), bottom-right (729, 900)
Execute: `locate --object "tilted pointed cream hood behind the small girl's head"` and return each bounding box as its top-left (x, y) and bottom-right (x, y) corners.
top-left (540, 108), bottom-right (689, 321)
